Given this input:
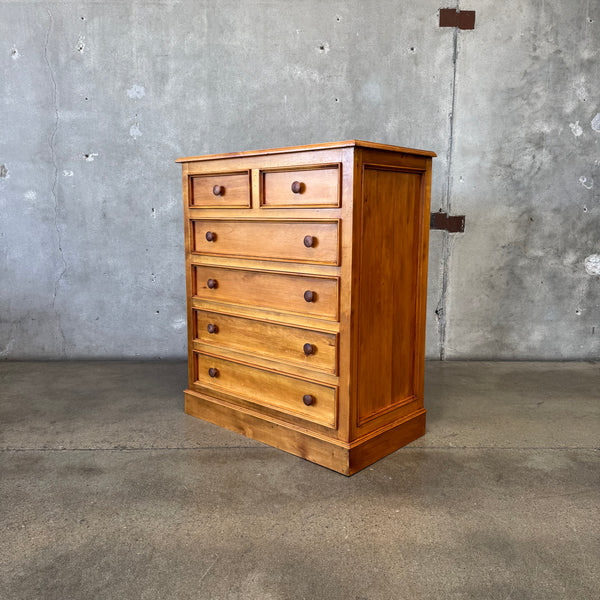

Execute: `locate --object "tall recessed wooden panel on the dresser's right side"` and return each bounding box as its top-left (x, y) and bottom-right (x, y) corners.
top-left (357, 165), bottom-right (423, 425)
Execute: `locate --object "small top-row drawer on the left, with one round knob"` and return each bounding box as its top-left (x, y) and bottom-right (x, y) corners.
top-left (190, 171), bottom-right (250, 208)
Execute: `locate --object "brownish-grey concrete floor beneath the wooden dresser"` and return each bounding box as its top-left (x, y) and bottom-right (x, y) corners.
top-left (0, 362), bottom-right (600, 600)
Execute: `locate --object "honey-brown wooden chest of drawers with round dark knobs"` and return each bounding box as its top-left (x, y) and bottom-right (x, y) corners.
top-left (178, 140), bottom-right (435, 475)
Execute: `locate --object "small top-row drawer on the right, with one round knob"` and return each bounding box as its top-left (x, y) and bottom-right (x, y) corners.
top-left (261, 165), bottom-right (341, 208)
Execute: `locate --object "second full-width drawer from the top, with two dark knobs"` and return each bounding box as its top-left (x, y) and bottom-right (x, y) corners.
top-left (192, 265), bottom-right (338, 320)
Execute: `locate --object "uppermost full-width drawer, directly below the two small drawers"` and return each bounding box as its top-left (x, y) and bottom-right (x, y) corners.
top-left (191, 219), bottom-right (339, 265)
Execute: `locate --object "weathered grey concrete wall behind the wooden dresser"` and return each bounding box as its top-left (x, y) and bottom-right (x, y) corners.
top-left (0, 0), bottom-right (600, 359)
